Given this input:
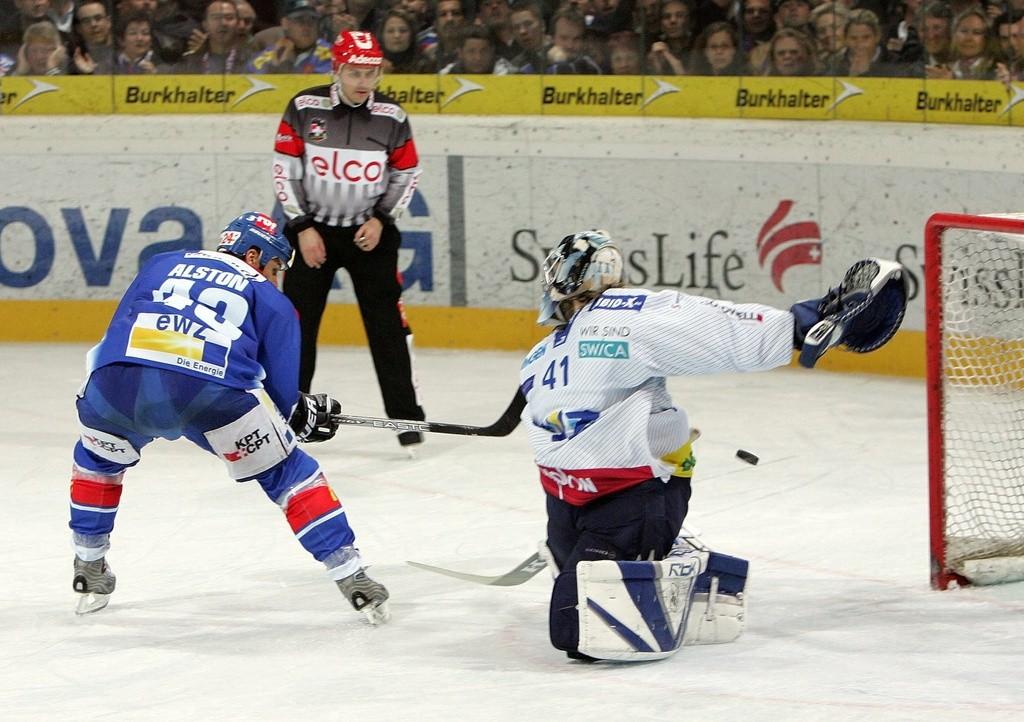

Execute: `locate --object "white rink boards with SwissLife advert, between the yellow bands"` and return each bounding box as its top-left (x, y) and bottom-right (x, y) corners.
top-left (0, 115), bottom-right (1024, 348)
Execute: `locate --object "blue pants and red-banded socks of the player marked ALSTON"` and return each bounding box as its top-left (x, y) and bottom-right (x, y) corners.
top-left (69, 364), bottom-right (355, 568)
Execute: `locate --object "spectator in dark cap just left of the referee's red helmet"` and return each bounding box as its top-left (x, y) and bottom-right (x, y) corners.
top-left (246, 0), bottom-right (331, 75)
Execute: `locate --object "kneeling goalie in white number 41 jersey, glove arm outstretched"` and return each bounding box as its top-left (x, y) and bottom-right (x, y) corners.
top-left (520, 231), bottom-right (906, 660)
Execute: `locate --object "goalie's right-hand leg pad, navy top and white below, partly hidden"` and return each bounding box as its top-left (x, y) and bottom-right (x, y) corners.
top-left (684, 552), bottom-right (750, 644)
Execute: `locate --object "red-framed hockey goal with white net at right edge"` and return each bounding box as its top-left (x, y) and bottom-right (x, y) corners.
top-left (925, 213), bottom-right (1024, 589)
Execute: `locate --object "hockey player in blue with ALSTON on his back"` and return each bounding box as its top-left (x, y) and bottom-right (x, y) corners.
top-left (70, 212), bottom-right (388, 624)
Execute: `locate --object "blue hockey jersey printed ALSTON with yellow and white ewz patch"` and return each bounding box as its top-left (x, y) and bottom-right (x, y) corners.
top-left (87, 251), bottom-right (299, 418)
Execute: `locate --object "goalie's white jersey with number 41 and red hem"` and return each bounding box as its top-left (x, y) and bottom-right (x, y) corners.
top-left (520, 288), bottom-right (794, 506)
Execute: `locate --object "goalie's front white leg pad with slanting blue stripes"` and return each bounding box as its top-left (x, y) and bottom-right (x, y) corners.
top-left (577, 553), bottom-right (706, 662)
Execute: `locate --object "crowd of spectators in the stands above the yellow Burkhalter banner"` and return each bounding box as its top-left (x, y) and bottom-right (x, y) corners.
top-left (0, 0), bottom-right (1024, 83)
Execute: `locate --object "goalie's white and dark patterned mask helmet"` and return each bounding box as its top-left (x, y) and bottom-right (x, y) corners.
top-left (537, 230), bottom-right (623, 325)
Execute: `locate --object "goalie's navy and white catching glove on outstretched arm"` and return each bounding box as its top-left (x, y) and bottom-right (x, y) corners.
top-left (790, 258), bottom-right (908, 369)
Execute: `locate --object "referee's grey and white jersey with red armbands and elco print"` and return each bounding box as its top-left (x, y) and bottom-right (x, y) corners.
top-left (273, 84), bottom-right (420, 226)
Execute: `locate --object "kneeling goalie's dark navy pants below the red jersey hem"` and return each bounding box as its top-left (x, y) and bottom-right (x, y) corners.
top-left (547, 476), bottom-right (690, 652)
